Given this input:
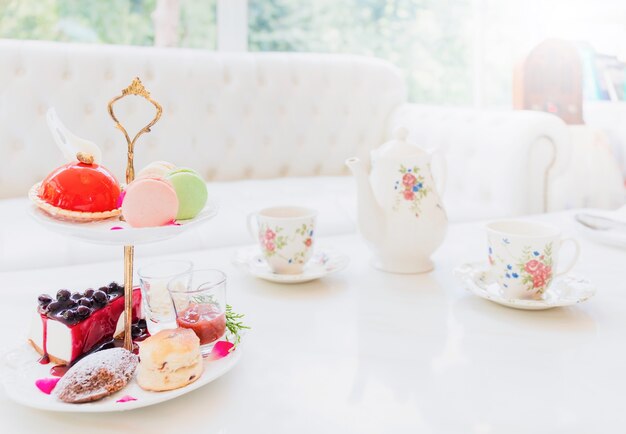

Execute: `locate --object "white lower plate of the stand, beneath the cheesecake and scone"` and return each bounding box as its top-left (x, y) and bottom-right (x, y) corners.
top-left (0, 343), bottom-right (241, 413)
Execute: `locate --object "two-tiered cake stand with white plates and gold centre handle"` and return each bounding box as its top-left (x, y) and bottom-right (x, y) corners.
top-left (0, 78), bottom-right (249, 413)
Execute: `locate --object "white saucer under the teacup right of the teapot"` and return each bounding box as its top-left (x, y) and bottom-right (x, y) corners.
top-left (454, 262), bottom-right (596, 310)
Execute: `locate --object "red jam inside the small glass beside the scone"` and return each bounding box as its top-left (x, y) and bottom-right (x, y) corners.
top-left (176, 303), bottom-right (226, 345)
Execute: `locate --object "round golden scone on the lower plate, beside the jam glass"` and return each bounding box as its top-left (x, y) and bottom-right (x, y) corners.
top-left (137, 328), bottom-right (204, 392)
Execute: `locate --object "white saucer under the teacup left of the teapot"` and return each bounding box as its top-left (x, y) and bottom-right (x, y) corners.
top-left (233, 246), bottom-right (349, 283)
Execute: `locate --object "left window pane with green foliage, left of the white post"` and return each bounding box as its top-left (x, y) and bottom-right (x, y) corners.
top-left (0, 0), bottom-right (216, 49)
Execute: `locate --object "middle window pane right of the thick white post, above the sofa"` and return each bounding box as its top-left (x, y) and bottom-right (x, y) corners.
top-left (248, 0), bottom-right (472, 104)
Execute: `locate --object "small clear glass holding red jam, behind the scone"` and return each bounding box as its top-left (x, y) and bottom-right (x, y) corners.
top-left (167, 269), bottom-right (226, 356)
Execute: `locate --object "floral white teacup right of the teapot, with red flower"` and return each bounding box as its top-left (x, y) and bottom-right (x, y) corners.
top-left (487, 220), bottom-right (580, 299)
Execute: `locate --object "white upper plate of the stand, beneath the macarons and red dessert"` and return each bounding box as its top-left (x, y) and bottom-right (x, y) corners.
top-left (30, 200), bottom-right (218, 246)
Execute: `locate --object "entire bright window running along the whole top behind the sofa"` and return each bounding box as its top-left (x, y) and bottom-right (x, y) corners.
top-left (0, 0), bottom-right (626, 108)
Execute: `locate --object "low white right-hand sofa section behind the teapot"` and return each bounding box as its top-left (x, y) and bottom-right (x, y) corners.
top-left (387, 104), bottom-right (569, 221)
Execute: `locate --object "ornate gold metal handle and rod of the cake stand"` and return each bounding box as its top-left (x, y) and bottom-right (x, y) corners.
top-left (109, 77), bottom-right (163, 351)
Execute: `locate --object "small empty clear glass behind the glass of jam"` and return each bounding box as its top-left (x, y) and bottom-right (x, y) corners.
top-left (137, 261), bottom-right (193, 334)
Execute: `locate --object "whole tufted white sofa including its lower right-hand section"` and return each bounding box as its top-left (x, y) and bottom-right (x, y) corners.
top-left (0, 40), bottom-right (567, 270)
